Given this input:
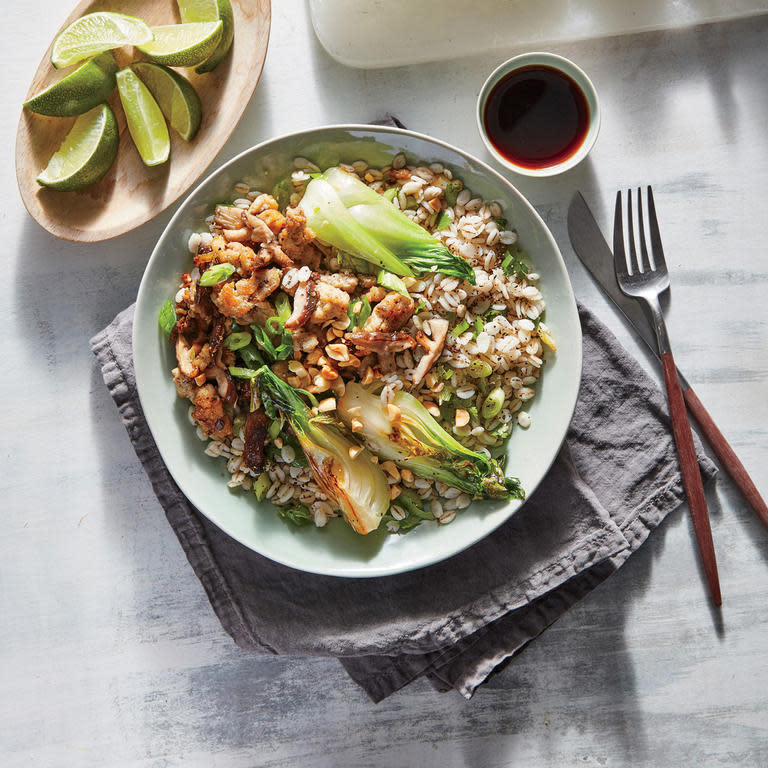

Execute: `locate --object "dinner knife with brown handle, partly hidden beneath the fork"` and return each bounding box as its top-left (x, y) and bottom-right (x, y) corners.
top-left (568, 192), bottom-right (768, 527)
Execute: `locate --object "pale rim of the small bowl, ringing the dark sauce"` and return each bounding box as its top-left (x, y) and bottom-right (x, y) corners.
top-left (475, 51), bottom-right (600, 178)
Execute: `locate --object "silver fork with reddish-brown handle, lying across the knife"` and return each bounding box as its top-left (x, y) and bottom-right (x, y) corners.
top-left (613, 186), bottom-right (722, 606)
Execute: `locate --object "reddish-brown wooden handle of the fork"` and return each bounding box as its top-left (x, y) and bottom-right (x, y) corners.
top-left (661, 352), bottom-right (723, 605)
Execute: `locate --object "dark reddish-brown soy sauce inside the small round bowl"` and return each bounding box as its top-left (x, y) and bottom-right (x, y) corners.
top-left (483, 65), bottom-right (589, 169)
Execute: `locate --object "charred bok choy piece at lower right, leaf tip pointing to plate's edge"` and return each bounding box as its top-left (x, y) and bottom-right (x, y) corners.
top-left (338, 382), bottom-right (525, 499)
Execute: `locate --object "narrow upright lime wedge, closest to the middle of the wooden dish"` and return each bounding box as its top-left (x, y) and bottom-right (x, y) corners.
top-left (116, 67), bottom-right (171, 165)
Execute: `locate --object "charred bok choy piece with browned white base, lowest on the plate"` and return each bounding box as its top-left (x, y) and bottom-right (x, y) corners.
top-left (254, 366), bottom-right (389, 534)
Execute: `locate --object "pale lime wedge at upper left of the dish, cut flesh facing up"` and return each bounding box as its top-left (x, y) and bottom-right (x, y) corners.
top-left (51, 11), bottom-right (152, 69)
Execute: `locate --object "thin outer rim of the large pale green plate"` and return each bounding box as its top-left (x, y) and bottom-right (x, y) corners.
top-left (131, 123), bottom-right (583, 578)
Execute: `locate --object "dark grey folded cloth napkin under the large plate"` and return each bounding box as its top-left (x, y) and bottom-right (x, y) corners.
top-left (91, 306), bottom-right (716, 701)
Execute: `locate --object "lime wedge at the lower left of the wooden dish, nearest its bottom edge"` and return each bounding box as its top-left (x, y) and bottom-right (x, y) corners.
top-left (37, 104), bottom-right (120, 191)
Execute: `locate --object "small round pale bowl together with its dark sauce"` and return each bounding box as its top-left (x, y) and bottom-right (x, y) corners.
top-left (477, 53), bottom-right (600, 177)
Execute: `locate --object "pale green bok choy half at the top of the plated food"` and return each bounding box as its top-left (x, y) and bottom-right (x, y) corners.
top-left (299, 168), bottom-right (475, 285)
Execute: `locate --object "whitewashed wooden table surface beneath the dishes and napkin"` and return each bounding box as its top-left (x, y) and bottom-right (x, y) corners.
top-left (0, 0), bottom-right (768, 768)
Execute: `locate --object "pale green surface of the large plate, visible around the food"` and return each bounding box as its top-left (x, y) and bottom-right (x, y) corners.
top-left (133, 125), bottom-right (581, 577)
